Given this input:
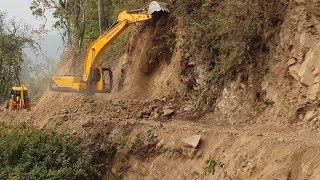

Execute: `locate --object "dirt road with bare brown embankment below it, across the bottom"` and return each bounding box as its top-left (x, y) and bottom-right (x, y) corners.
top-left (1, 97), bottom-right (320, 179)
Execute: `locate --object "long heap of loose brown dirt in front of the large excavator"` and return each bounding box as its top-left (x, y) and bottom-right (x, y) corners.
top-left (31, 92), bottom-right (183, 128)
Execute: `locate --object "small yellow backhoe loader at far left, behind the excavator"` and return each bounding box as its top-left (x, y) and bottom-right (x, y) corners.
top-left (6, 84), bottom-right (31, 111)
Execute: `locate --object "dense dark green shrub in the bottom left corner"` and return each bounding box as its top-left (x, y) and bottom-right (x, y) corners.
top-left (0, 127), bottom-right (100, 180)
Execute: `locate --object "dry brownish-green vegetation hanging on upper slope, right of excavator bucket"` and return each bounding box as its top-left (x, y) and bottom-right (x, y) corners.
top-left (177, 0), bottom-right (286, 83)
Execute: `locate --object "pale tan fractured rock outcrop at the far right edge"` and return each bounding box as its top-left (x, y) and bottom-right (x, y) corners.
top-left (287, 17), bottom-right (320, 101)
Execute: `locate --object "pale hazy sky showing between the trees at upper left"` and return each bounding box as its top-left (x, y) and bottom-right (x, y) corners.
top-left (0, 0), bottom-right (63, 62)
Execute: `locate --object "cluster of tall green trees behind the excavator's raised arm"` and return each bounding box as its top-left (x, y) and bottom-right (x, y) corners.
top-left (30, 0), bottom-right (145, 48)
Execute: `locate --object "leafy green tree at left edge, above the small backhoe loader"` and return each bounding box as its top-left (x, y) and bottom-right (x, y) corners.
top-left (0, 13), bottom-right (34, 101)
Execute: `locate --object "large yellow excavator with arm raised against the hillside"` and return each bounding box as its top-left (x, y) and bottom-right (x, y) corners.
top-left (49, 1), bottom-right (169, 93)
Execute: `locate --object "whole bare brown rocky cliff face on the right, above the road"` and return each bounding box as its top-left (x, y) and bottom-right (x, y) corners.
top-left (210, 0), bottom-right (320, 129)
